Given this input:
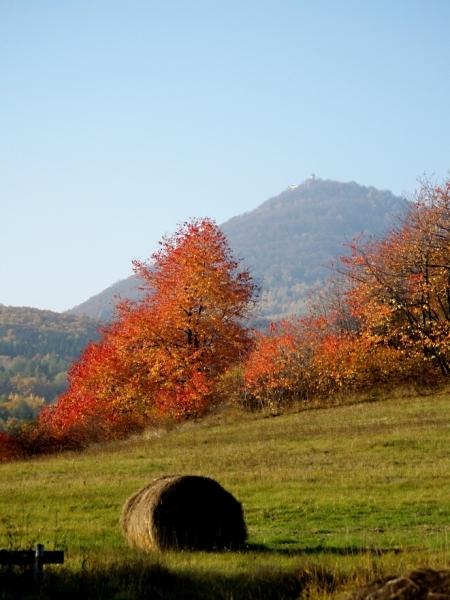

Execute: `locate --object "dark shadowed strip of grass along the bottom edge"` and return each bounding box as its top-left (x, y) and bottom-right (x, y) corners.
top-left (0, 557), bottom-right (333, 600)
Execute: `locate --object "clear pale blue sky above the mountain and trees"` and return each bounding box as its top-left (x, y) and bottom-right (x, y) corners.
top-left (0, 0), bottom-right (450, 310)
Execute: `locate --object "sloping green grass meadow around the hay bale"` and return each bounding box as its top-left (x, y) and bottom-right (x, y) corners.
top-left (0, 391), bottom-right (450, 599)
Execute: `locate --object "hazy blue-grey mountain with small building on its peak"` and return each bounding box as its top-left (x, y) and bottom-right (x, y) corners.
top-left (68, 177), bottom-right (408, 319)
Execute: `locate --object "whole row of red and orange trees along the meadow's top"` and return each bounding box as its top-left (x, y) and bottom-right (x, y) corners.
top-left (0, 180), bottom-right (450, 455)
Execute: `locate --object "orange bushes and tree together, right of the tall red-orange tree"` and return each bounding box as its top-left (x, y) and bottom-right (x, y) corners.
top-left (244, 181), bottom-right (450, 407)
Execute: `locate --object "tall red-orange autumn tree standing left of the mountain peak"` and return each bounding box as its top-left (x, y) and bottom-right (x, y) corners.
top-left (40, 219), bottom-right (257, 438)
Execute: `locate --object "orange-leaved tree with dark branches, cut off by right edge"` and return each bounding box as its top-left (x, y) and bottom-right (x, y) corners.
top-left (344, 181), bottom-right (450, 376)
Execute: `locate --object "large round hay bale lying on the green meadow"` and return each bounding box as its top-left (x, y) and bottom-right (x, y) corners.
top-left (121, 475), bottom-right (247, 550)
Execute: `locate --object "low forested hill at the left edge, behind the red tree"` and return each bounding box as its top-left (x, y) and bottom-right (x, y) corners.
top-left (0, 305), bottom-right (98, 429)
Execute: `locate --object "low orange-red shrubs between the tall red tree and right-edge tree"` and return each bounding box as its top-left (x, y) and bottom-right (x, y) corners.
top-left (244, 284), bottom-right (426, 409)
